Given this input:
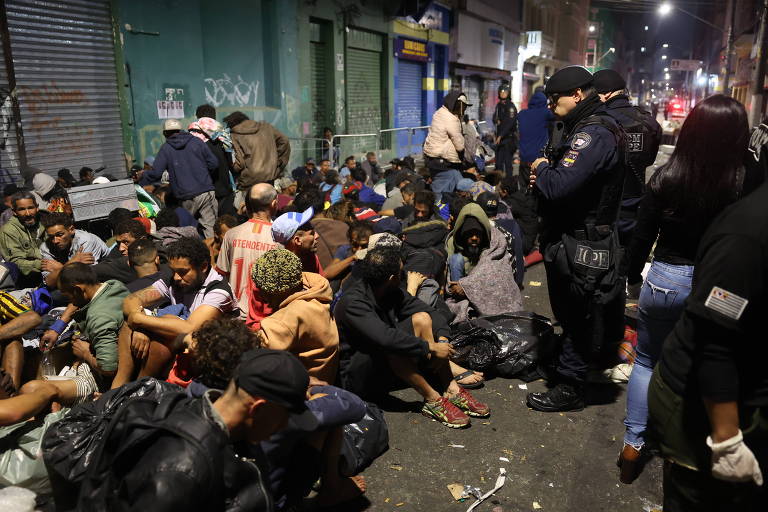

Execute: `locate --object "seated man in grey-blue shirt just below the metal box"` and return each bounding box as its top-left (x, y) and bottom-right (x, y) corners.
top-left (40, 213), bottom-right (109, 289)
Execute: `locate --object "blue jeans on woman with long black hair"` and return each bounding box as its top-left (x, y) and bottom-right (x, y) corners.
top-left (624, 261), bottom-right (693, 450)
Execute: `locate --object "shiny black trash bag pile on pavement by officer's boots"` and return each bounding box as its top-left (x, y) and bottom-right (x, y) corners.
top-left (450, 311), bottom-right (556, 382)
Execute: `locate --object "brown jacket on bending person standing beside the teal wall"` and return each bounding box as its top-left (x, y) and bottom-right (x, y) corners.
top-left (231, 119), bottom-right (291, 190)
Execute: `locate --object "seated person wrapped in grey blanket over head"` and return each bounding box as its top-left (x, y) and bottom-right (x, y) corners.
top-left (445, 203), bottom-right (523, 324)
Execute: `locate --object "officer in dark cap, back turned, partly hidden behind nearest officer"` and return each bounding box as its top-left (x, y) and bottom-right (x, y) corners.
top-left (594, 69), bottom-right (661, 256)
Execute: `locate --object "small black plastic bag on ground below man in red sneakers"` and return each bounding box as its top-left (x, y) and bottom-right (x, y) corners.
top-left (339, 402), bottom-right (389, 476)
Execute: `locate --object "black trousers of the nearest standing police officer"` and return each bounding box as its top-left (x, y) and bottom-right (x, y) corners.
top-left (544, 261), bottom-right (624, 384)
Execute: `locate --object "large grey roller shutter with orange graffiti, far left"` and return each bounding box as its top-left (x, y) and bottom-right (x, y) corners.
top-left (5, 0), bottom-right (125, 177)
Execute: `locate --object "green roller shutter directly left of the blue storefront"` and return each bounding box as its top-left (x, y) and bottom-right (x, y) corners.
top-left (341, 30), bottom-right (383, 158)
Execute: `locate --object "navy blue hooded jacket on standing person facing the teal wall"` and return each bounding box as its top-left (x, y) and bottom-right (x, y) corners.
top-left (141, 132), bottom-right (219, 201)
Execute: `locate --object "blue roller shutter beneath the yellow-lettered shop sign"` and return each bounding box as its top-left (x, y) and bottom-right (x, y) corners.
top-left (395, 59), bottom-right (424, 157)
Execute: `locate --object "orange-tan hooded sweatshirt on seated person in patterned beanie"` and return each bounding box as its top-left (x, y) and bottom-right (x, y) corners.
top-left (261, 272), bottom-right (339, 384)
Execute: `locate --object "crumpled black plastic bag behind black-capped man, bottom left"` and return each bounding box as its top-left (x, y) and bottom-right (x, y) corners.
top-left (42, 378), bottom-right (180, 509)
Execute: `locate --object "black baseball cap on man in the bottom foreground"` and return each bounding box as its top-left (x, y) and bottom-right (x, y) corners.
top-left (234, 348), bottom-right (319, 431)
